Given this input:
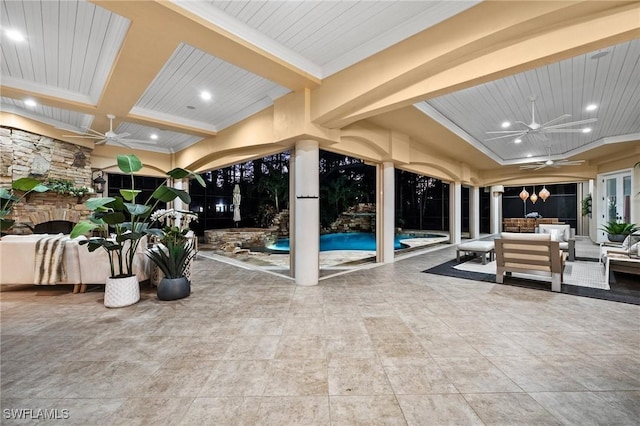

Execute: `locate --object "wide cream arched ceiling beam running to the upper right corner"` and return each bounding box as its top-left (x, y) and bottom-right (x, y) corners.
top-left (312, 2), bottom-right (640, 128)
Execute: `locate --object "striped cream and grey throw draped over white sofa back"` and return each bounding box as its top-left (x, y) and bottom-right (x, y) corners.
top-left (34, 235), bottom-right (69, 285)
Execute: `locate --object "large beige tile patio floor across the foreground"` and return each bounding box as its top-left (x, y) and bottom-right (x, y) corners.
top-left (0, 248), bottom-right (640, 425)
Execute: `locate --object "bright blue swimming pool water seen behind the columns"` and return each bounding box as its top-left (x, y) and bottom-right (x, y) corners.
top-left (267, 232), bottom-right (442, 252)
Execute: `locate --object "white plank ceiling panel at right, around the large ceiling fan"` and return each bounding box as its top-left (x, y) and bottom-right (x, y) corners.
top-left (416, 39), bottom-right (640, 164)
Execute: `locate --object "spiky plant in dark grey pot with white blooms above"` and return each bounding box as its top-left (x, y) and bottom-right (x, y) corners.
top-left (147, 209), bottom-right (198, 300)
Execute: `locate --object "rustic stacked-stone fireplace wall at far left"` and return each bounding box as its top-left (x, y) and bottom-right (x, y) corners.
top-left (0, 127), bottom-right (92, 234)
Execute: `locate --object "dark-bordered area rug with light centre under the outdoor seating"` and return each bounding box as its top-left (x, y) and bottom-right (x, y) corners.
top-left (422, 258), bottom-right (640, 305)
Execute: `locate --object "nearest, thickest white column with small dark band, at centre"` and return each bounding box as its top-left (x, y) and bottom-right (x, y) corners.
top-left (293, 140), bottom-right (320, 285)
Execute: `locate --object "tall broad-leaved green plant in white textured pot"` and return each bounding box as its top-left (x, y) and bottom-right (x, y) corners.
top-left (70, 154), bottom-right (205, 308)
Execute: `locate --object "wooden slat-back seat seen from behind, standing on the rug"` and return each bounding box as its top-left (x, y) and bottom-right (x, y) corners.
top-left (494, 232), bottom-right (566, 292)
